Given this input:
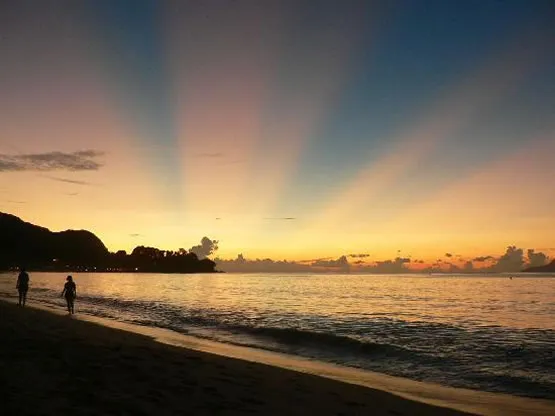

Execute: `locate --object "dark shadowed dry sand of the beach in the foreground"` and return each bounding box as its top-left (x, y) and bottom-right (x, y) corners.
top-left (0, 301), bottom-right (474, 416)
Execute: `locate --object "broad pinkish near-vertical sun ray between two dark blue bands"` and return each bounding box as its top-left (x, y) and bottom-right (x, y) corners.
top-left (171, 3), bottom-right (384, 239)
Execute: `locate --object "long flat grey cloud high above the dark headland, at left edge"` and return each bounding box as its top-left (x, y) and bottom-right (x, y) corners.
top-left (0, 150), bottom-right (104, 172)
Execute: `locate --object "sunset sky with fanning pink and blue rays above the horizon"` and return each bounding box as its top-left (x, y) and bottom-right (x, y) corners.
top-left (0, 0), bottom-right (555, 267)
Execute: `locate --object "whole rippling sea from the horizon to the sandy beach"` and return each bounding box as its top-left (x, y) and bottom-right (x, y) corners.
top-left (0, 273), bottom-right (555, 399)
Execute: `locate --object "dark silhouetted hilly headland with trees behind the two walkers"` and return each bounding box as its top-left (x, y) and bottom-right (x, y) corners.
top-left (0, 212), bottom-right (216, 273)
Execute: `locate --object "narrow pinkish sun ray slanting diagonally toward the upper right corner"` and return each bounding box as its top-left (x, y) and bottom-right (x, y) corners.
top-left (295, 22), bottom-right (548, 244)
